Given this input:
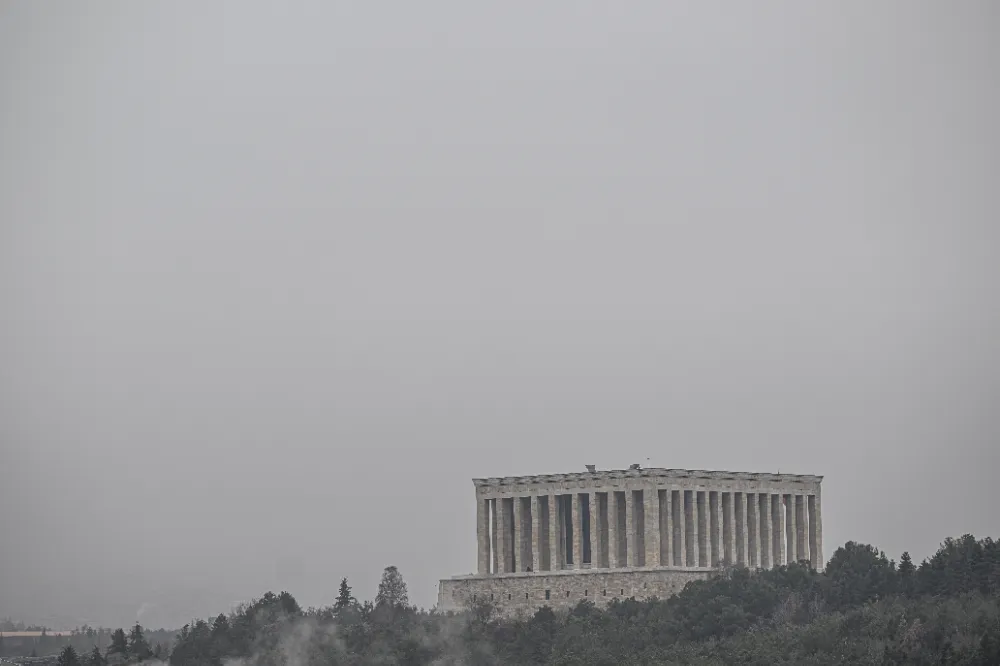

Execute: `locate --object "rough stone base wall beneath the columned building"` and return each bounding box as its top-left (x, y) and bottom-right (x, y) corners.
top-left (438, 567), bottom-right (718, 615)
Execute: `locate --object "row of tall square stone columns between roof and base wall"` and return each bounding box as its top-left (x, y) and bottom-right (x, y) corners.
top-left (477, 474), bottom-right (823, 576)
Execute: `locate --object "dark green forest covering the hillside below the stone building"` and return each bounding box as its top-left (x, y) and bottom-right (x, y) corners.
top-left (5, 536), bottom-right (1000, 666)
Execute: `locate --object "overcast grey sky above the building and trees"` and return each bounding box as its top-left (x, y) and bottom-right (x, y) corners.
top-left (0, 0), bottom-right (1000, 626)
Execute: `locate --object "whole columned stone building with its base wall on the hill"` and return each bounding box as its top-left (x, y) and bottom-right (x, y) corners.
top-left (438, 465), bottom-right (824, 613)
